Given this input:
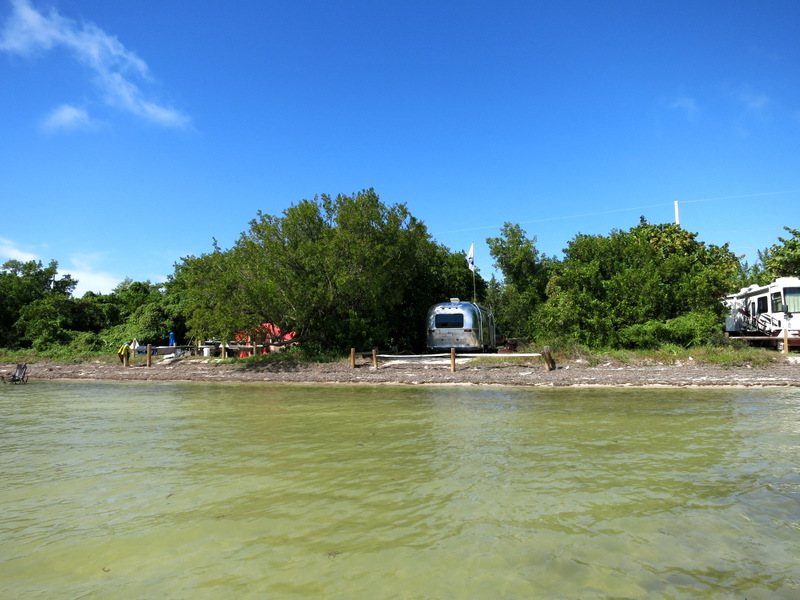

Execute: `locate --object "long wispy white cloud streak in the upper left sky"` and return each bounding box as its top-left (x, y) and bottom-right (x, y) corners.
top-left (0, 0), bottom-right (189, 127)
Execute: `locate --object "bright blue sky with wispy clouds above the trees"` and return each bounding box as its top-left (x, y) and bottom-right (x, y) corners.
top-left (0, 0), bottom-right (800, 295)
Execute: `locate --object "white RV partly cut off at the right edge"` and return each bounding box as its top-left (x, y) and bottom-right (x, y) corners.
top-left (724, 277), bottom-right (800, 347)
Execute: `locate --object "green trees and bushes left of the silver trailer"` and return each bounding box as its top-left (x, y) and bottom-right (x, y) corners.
top-left (0, 189), bottom-right (488, 351)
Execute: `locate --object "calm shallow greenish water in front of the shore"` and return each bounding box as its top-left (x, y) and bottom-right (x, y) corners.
top-left (0, 381), bottom-right (800, 600)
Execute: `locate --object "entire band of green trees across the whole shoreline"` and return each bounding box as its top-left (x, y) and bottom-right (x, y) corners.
top-left (0, 189), bottom-right (800, 353)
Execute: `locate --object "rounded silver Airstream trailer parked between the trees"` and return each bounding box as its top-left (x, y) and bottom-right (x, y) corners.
top-left (428, 298), bottom-right (497, 352)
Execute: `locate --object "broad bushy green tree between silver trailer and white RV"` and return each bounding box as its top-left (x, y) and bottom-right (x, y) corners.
top-left (537, 218), bottom-right (740, 347)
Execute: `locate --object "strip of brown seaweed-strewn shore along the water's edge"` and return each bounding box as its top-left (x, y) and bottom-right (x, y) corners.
top-left (10, 357), bottom-right (800, 387)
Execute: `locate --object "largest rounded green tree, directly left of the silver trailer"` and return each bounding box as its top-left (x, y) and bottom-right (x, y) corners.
top-left (174, 190), bottom-right (486, 349)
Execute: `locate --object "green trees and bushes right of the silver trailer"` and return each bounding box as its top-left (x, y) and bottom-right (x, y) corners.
top-left (487, 224), bottom-right (800, 348)
